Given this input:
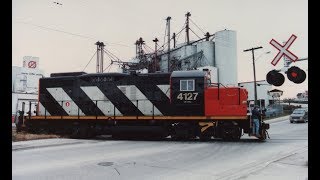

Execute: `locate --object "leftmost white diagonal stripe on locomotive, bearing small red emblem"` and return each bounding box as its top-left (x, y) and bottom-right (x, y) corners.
top-left (47, 87), bottom-right (85, 116)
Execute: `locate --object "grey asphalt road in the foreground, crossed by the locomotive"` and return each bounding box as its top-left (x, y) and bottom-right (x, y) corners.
top-left (12, 116), bottom-right (308, 180)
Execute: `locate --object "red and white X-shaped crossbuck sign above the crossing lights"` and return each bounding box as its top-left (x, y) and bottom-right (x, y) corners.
top-left (270, 34), bottom-right (298, 66)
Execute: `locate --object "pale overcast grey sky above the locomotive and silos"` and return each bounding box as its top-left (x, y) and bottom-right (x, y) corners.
top-left (12, 0), bottom-right (308, 97)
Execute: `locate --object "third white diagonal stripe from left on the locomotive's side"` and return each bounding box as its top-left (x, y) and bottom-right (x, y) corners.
top-left (117, 85), bottom-right (162, 115)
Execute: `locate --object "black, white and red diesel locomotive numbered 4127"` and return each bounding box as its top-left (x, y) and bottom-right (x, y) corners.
top-left (17, 70), bottom-right (269, 140)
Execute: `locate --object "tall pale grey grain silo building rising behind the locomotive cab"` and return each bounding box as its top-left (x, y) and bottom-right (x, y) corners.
top-left (159, 30), bottom-right (238, 86)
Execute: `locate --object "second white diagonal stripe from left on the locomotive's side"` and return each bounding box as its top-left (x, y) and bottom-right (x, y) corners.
top-left (80, 86), bottom-right (122, 116)
